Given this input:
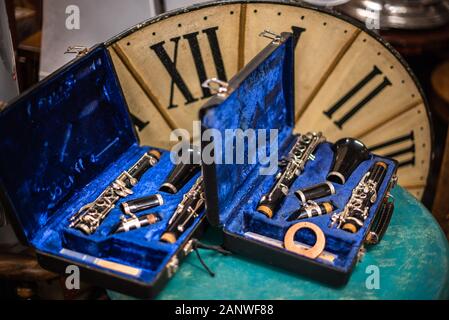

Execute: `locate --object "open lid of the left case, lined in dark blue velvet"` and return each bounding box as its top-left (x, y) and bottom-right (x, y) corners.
top-left (0, 46), bottom-right (137, 243)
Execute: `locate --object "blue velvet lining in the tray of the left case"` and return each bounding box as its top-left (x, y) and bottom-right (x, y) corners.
top-left (39, 145), bottom-right (204, 283)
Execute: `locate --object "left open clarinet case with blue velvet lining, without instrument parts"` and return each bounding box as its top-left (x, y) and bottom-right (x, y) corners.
top-left (0, 45), bottom-right (205, 298)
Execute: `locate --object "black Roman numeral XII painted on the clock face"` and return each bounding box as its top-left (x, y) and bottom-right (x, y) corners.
top-left (150, 27), bottom-right (228, 109)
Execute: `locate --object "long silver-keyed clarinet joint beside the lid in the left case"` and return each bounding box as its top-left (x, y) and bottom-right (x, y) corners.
top-left (69, 150), bottom-right (161, 235)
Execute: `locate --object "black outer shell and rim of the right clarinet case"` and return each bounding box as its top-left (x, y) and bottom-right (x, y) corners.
top-left (200, 33), bottom-right (397, 287)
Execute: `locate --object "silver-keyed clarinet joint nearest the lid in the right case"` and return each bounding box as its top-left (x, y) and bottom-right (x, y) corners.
top-left (257, 132), bottom-right (326, 219)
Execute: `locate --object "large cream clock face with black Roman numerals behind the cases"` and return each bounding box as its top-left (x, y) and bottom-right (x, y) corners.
top-left (108, 1), bottom-right (432, 198)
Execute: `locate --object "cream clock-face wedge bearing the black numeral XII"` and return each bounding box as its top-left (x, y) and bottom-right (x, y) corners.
top-left (114, 4), bottom-right (241, 140)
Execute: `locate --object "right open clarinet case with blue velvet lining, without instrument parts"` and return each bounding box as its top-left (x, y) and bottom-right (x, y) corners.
top-left (200, 33), bottom-right (397, 286)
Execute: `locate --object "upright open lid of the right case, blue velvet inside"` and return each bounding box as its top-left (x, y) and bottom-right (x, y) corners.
top-left (200, 33), bottom-right (295, 226)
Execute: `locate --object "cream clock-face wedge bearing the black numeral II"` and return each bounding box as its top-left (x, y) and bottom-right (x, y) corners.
top-left (297, 32), bottom-right (425, 139)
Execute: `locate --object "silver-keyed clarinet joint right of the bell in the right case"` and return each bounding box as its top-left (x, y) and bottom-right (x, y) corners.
top-left (331, 162), bottom-right (388, 233)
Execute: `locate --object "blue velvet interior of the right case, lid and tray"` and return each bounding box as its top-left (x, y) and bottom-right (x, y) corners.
top-left (202, 38), bottom-right (396, 273)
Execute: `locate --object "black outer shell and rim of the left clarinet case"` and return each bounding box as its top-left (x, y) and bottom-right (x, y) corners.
top-left (0, 44), bottom-right (207, 299)
